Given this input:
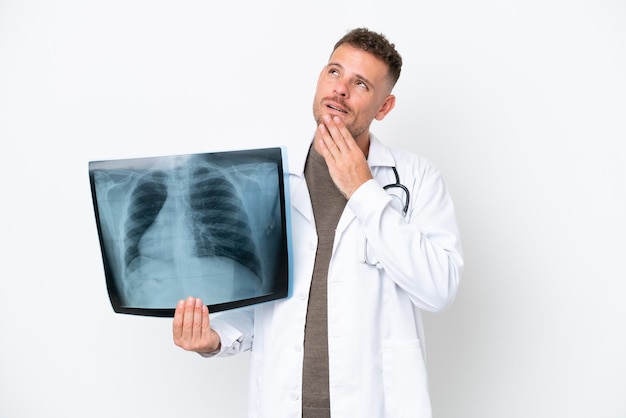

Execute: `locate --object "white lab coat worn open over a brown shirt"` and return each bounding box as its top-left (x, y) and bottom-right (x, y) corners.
top-left (212, 135), bottom-right (463, 418)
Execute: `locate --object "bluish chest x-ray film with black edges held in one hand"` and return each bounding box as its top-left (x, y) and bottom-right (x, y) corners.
top-left (89, 148), bottom-right (292, 317)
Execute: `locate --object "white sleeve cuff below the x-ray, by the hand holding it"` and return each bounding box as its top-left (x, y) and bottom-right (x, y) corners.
top-left (197, 307), bottom-right (254, 357)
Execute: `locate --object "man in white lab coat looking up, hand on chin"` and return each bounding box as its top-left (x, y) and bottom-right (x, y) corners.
top-left (173, 29), bottom-right (463, 418)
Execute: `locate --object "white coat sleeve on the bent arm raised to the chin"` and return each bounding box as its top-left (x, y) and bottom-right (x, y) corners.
top-left (348, 165), bottom-right (463, 311)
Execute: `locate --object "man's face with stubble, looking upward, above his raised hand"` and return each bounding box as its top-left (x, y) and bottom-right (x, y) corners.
top-left (313, 44), bottom-right (395, 145)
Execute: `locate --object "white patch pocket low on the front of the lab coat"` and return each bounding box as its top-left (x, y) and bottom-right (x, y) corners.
top-left (383, 339), bottom-right (432, 418)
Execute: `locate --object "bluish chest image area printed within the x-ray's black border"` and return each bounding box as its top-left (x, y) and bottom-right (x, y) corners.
top-left (95, 156), bottom-right (282, 308)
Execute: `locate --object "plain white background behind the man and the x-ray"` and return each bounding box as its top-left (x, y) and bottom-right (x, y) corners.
top-left (0, 0), bottom-right (626, 418)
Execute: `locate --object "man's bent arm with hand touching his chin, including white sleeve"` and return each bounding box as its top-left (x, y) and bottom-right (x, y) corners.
top-left (315, 113), bottom-right (463, 311)
